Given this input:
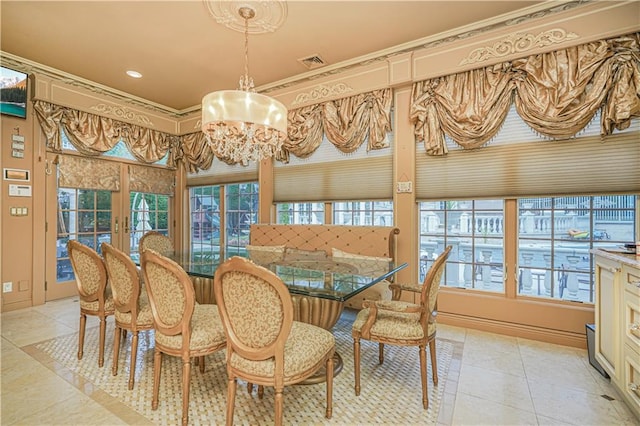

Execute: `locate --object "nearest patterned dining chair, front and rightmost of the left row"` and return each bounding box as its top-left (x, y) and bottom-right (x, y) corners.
top-left (214, 256), bottom-right (335, 425)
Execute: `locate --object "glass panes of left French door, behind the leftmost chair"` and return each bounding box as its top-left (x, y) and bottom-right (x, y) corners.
top-left (56, 188), bottom-right (111, 281)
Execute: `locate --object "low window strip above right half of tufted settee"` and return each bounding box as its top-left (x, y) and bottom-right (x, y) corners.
top-left (333, 201), bottom-right (393, 226)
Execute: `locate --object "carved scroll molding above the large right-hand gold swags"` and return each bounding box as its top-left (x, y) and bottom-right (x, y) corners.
top-left (460, 28), bottom-right (578, 65)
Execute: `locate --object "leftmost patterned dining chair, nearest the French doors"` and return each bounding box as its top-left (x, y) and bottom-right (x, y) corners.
top-left (67, 240), bottom-right (114, 367)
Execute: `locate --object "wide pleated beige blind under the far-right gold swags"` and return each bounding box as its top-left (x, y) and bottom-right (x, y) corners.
top-left (416, 113), bottom-right (640, 200)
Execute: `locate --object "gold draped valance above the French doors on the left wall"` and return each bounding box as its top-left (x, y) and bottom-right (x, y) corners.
top-left (34, 101), bottom-right (179, 167)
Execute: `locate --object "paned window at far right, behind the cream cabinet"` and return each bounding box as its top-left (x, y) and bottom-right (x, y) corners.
top-left (518, 195), bottom-right (636, 303)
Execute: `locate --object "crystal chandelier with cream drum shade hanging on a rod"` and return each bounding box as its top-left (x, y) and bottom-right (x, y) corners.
top-left (202, 6), bottom-right (287, 165)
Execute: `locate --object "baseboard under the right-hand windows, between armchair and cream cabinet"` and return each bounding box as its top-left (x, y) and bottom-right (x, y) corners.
top-left (438, 312), bottom-right (587, 349)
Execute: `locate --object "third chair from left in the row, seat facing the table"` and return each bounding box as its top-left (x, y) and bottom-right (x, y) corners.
top-left (141, 249), bottom-right (226, 425)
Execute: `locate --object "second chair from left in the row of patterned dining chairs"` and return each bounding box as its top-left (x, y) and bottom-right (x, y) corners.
top-left (102, 243), bottom-right (153, 389)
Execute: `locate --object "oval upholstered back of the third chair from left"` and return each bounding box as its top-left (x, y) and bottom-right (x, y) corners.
top-left (141, 249), bottom-right (195, 342)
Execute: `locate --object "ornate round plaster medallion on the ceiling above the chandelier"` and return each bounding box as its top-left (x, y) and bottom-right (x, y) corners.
top-left (203, 0), bottom-right (287, 34)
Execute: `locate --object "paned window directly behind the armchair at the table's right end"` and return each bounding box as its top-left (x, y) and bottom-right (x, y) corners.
top-left (419, 200), bottom-right (504, 292)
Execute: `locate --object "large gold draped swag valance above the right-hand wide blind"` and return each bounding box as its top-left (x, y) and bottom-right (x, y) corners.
top-left (410, 33), bottom-right (640, 156)
